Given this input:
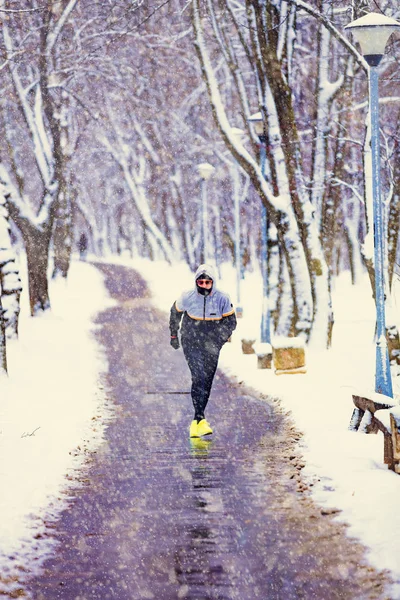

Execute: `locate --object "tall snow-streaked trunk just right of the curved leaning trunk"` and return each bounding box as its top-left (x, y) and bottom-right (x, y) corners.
top-left (248, 0), bottom-right (331, 347)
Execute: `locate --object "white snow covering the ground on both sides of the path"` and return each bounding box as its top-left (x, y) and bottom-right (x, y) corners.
top-left (0, 255), bottom-right (400, 600)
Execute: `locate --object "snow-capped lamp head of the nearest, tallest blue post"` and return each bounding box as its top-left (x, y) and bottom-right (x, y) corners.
top-left (345, 13), bottom-right (400, 67)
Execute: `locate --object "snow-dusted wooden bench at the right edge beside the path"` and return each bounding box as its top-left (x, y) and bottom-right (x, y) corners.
top-left (349, 394), bottom-right (400, 474)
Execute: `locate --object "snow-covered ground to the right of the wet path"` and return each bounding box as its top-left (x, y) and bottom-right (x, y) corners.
top-left (132, 255), bottom-right (400, 600)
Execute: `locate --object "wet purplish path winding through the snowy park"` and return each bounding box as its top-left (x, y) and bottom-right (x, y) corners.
top-left (29, 266), bottom-right (385, 600)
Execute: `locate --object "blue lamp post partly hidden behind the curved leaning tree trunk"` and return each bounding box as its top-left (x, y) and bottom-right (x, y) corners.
top-left (249, 112), bottom-right (271, 344)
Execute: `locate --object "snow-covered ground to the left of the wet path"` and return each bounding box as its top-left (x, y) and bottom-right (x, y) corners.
top-left (0, 255), bottom-right (115, 597)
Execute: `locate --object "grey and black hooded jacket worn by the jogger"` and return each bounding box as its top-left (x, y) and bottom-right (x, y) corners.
top-left (170, 264), bottom-right (236, 352)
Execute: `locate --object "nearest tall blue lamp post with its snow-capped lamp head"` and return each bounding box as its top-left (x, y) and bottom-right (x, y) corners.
top-left (345, 13), bottom-right (400, 398)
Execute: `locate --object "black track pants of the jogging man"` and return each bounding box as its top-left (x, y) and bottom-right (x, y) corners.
top-left (182, 344), bottom-right (219, 419)
